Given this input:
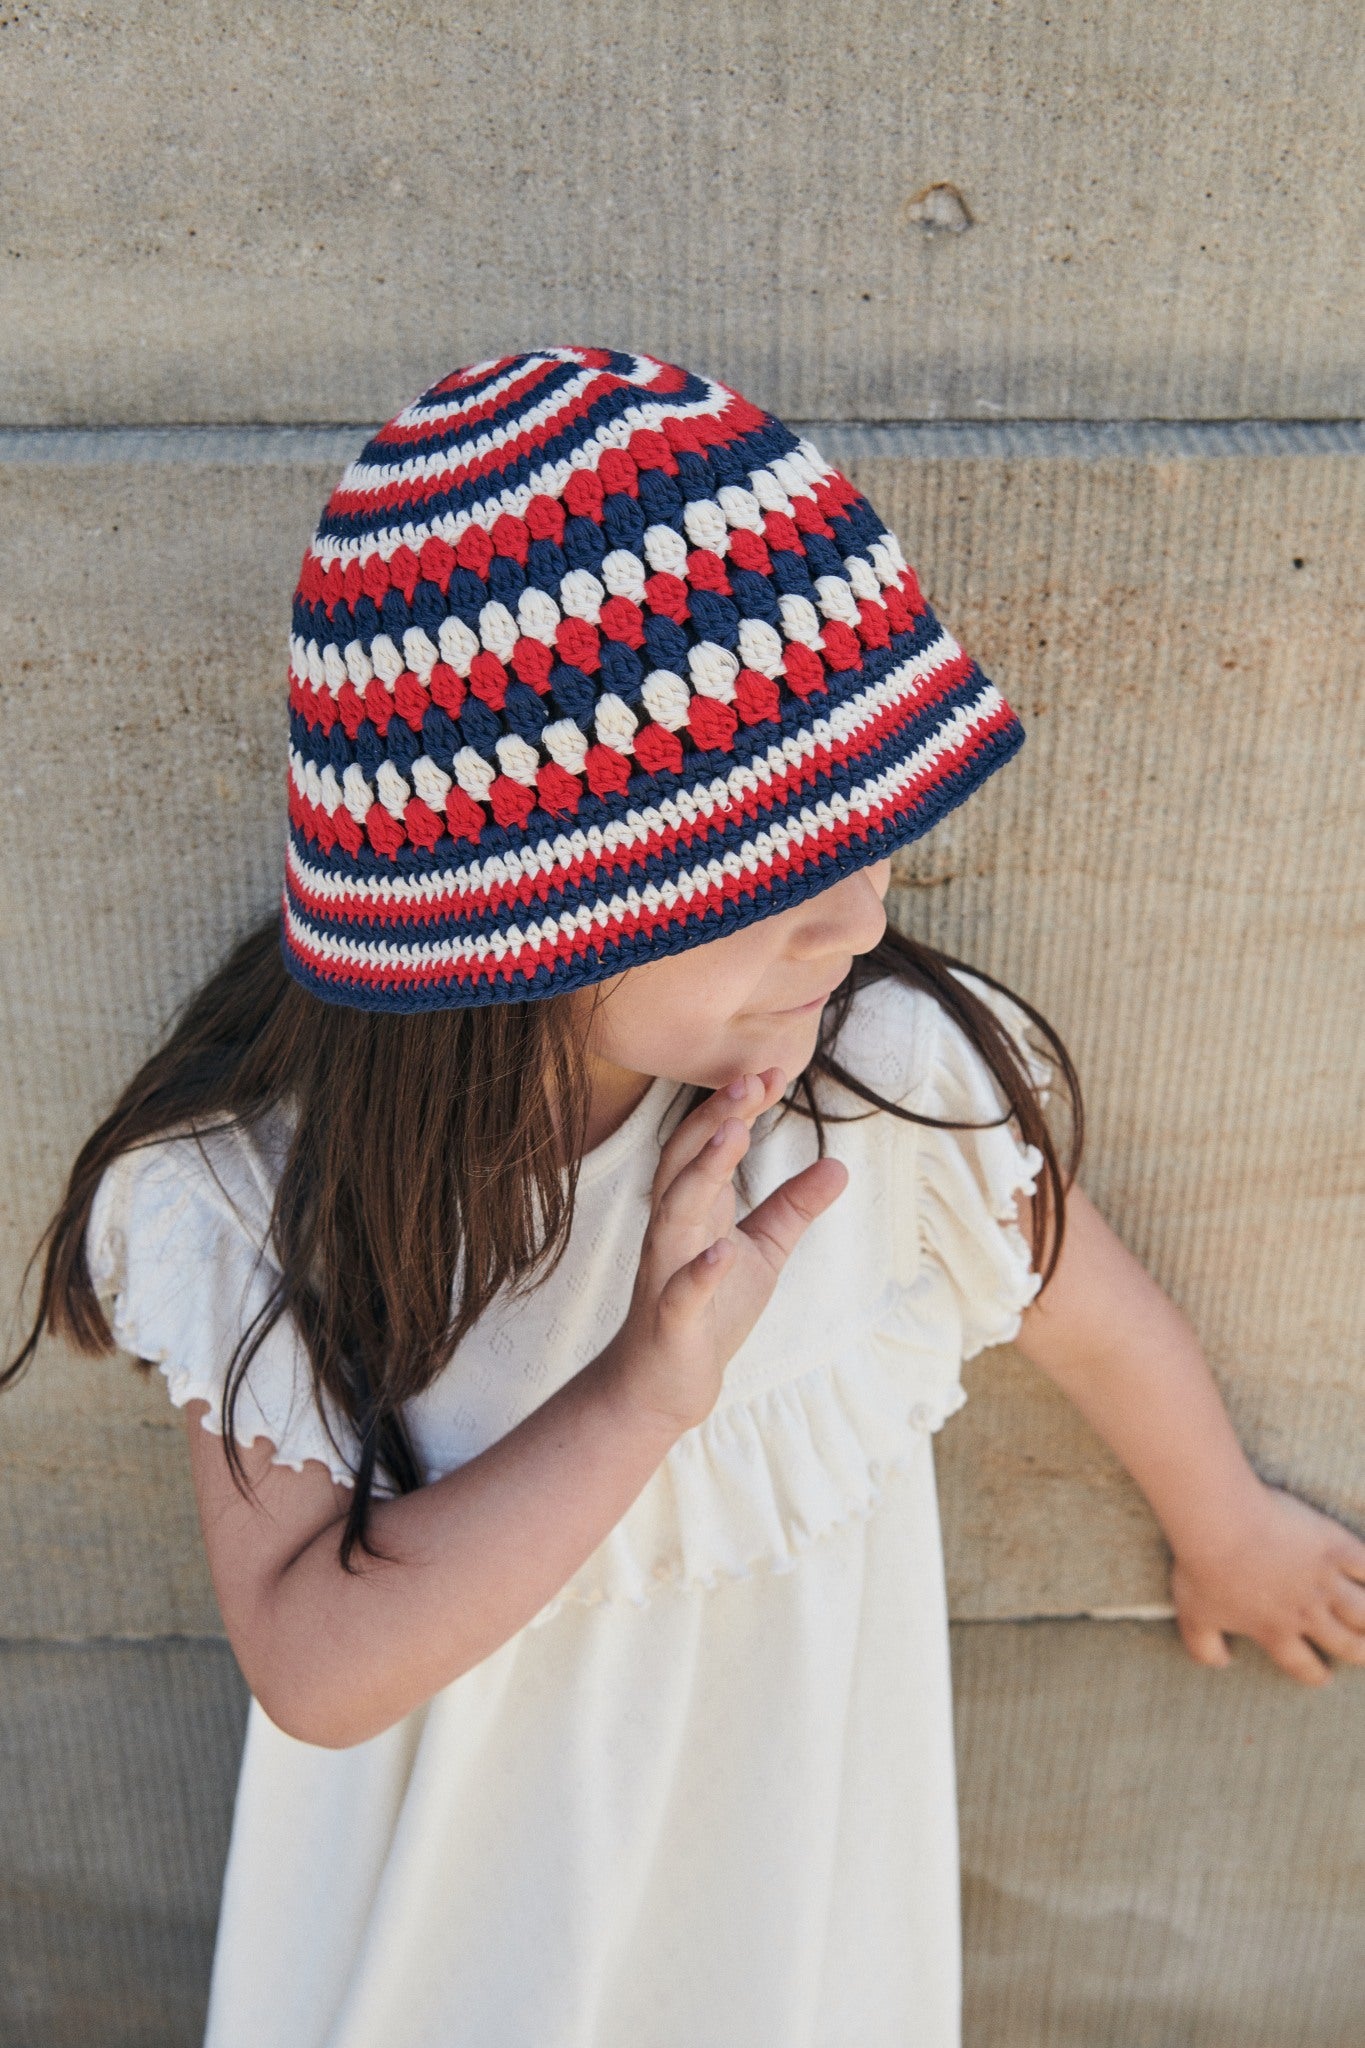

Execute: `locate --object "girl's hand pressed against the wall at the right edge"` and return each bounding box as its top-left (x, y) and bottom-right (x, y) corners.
top-left (1171, 1485), bottom-right (1365, 1686)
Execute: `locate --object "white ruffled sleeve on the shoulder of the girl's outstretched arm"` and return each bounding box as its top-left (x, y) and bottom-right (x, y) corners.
top-left (907, 973), bottom-right (1052, 1358)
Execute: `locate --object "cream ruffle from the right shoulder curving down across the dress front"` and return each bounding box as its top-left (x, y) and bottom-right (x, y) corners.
top-left (530, 985), bottom-right (1048, 1628)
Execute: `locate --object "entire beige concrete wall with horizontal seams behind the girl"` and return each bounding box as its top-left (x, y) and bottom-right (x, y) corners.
top-left (0, 0), bottom-right (1365, 2048)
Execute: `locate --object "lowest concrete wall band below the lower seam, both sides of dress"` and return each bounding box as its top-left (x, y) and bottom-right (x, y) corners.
top-left (0, 1622), bottom-right (1365, 2048)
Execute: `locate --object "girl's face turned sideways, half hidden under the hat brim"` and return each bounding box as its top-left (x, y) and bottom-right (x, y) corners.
top-left (587, 860), bottom-right (890, 1087)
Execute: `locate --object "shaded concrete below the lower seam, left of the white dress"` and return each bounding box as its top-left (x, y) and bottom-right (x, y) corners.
top-left (0, 1642), bottom-right (248, 2048)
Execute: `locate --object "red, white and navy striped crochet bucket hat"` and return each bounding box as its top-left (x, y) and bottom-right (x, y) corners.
top-left (282, 348), bottom-right (1023, 1012)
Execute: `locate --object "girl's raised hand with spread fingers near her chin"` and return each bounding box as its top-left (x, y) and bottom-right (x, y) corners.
top-left (598, 1067), bottom-right (847, 1434)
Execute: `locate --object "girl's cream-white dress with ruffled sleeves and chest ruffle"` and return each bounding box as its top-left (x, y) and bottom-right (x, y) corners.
top-left (88, 966), bottom-right (1044, 2048)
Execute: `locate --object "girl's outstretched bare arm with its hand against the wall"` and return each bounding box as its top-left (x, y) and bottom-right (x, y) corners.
top-left (1015, 1188), bottom-right (1365, 1686)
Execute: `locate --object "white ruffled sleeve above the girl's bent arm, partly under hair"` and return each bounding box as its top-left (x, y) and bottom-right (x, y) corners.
top-left (86, 1130), bottom-right (354, 1485)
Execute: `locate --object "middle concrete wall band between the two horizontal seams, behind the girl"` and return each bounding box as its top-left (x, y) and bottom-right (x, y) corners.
top-left (0, 430), bottom-right (1365, 1636)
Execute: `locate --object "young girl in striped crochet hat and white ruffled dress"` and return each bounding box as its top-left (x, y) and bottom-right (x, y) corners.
top-left (16, 348), bottom-right (1365, 2048)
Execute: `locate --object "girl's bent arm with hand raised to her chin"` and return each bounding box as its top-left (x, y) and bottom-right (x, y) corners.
top-left (186, 1069), bottom-right (847, 1749)
